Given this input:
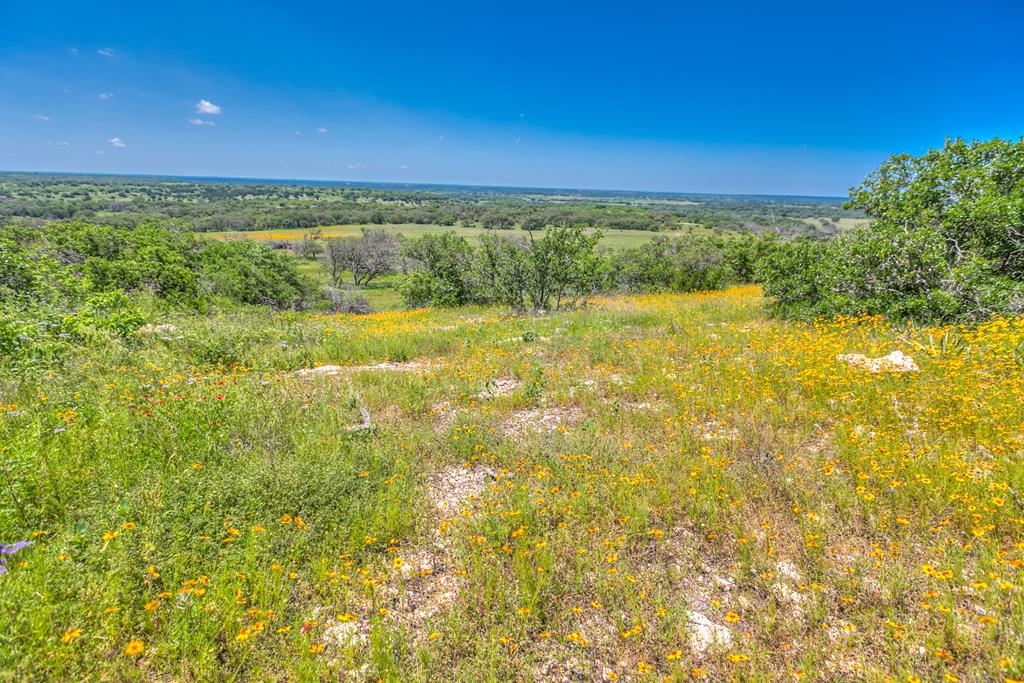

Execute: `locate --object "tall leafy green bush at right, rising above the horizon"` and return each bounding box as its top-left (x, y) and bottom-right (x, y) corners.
top-left (760, 138), bottom-right (1024, 322)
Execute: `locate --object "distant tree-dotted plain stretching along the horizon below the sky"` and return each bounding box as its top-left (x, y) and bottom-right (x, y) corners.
top-left (0, 173), bottom-right (860, 237)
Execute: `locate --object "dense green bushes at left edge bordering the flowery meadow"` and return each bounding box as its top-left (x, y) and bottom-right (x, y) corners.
top-left (0, 222), bottom-right (312, 362)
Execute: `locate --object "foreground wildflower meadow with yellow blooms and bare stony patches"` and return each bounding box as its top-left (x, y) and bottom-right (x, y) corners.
top-left (0, 288), bottom-right (1024, 681)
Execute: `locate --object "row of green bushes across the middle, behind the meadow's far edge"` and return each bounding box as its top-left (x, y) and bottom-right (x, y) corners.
top-left (399, 227), bottom-right (778, 311)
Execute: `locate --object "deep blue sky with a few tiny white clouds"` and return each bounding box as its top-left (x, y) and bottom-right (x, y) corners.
top-left (0, 0), bottom-right (1024, 195)
